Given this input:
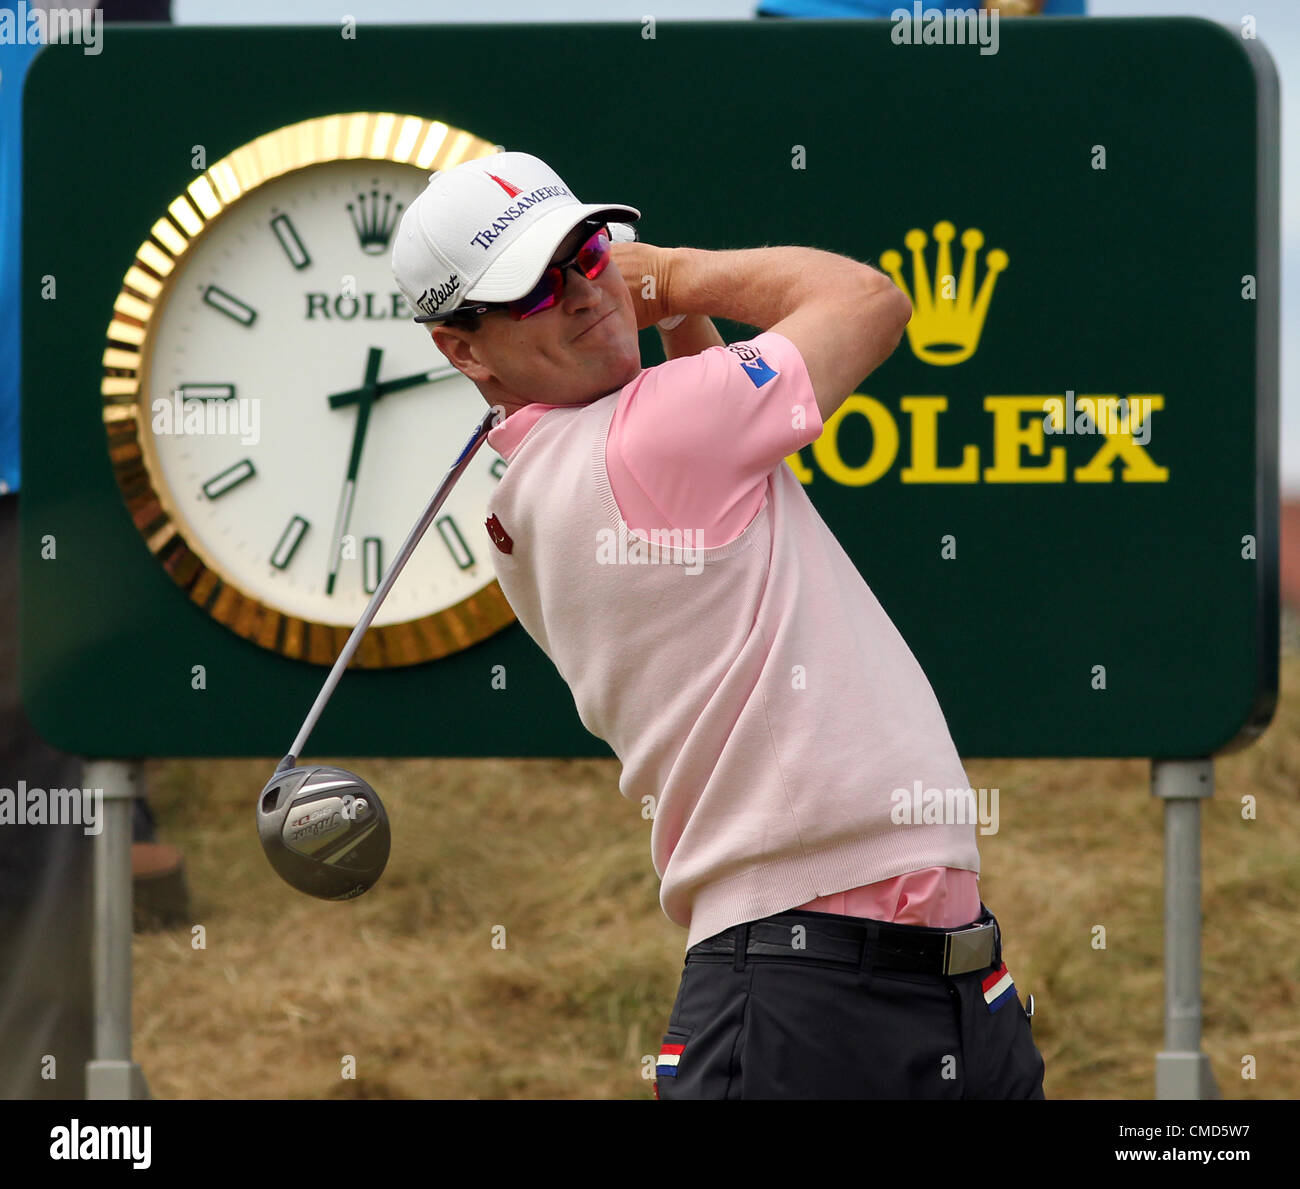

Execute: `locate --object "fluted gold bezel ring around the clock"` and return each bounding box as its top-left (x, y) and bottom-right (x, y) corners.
top-left (100, 112), bottom-right (515, 668)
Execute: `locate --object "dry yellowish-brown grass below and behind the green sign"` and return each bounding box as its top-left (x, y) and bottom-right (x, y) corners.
top-left (135, 658), bottom-right (1300, 1098)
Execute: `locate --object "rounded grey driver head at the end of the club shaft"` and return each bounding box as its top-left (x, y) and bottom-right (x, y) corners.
top-left (257, 765), bottom-right (393, 901)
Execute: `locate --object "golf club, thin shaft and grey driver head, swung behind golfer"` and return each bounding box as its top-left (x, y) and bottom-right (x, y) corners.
top-left (257, 408), bottom-right (501, 901)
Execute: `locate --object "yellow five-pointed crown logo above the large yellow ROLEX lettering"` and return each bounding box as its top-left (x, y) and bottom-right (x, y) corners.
top-left (880, 220), bottom-right (1010, 368)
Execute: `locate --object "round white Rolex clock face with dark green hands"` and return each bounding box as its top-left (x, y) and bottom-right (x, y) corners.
top-left (105, 117), bottom-right (512, 664)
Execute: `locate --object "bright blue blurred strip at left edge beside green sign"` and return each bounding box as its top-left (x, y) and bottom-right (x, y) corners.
top-left (0, 4), bottom-right (44, 495)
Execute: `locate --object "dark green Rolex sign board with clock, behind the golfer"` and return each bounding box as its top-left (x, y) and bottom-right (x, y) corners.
top-left (21, 19), bottom-right (1278, 756)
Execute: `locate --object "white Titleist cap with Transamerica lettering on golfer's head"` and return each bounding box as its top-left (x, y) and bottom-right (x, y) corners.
top-left (393, 153), bottom-right (641, 321)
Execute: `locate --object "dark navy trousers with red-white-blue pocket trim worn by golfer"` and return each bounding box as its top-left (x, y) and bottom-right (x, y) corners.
top-left (655, 906), bottom-right (1044, 1101)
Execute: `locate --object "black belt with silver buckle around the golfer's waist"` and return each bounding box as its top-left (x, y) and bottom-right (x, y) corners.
top-left (686, 908), bottom-right (1002, 975)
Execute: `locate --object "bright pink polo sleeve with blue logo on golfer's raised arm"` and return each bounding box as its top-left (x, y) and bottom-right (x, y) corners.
top-left (606, 330), bottom-right (822, 547)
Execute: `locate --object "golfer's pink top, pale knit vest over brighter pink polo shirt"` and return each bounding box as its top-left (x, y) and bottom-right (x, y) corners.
top-left (488, 333), bottom-right (979, 947)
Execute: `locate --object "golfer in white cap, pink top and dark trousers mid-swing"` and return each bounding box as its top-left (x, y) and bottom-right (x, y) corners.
top-left (393, 152), bottom-right (1044, 1099)
